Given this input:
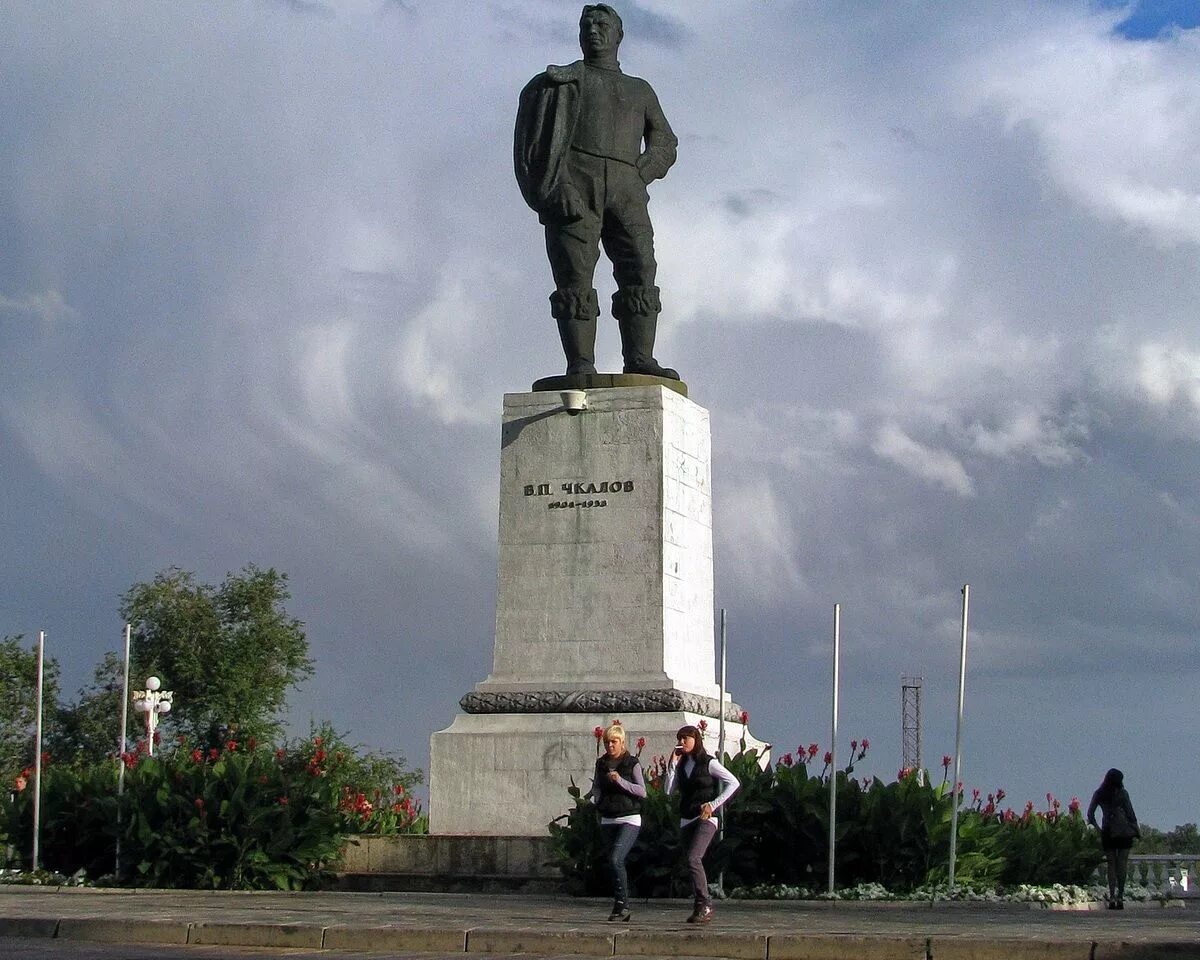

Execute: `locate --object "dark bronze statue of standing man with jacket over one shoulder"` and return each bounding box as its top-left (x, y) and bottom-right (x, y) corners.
top-left (514, 4), bottom-right (679, 380)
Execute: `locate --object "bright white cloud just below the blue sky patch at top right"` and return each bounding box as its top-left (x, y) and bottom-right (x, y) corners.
top-left (956, 12), bottom-right (1200, 244)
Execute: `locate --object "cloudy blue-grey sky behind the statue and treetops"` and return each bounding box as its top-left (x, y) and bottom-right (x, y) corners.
top-left (0, 0), bottom-right (1200, 827)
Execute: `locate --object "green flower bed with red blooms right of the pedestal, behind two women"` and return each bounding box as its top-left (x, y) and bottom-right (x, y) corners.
top-left (550, 742), bottom-right (1103, 896)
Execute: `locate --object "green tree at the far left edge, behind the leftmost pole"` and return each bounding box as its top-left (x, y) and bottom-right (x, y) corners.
top-left (0, 635), bottom-right (59, 790)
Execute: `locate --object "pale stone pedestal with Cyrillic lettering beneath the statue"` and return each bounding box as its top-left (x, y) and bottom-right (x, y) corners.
top-left (430, 378), bottom-right (760, 835)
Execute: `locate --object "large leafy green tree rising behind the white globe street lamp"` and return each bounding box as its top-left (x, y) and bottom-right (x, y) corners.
top-left (121, 564), bottom-right (312, 744)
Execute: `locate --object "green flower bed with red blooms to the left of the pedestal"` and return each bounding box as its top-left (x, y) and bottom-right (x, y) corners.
top-left (5, 727), bottom-right (427, 890)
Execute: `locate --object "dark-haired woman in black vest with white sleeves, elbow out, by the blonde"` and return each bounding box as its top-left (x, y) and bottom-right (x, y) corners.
top-left (666, 724), bottom-right (740, 923)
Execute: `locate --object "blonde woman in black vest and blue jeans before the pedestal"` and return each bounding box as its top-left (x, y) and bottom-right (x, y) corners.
top-left (588, 722), bottom-right (646, 922)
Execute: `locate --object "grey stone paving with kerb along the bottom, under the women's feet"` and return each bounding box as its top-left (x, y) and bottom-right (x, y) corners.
top-left (0, 887), bottom-right (1200, 960)
